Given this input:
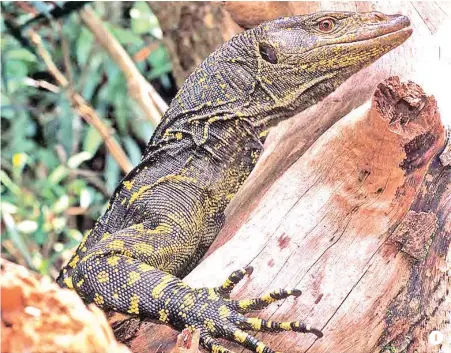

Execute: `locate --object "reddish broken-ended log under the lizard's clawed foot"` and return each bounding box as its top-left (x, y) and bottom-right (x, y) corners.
top-left (117, 75), bottom-right (451, 352)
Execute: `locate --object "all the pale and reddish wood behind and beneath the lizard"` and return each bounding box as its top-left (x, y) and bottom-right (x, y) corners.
top-left (111, 2), bottom-right (451, 353)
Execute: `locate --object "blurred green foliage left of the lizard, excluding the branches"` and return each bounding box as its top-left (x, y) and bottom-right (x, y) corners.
top-left (0, 1), bottom-right (171, 276)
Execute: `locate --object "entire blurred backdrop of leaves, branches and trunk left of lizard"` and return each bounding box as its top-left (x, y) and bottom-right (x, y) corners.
top-left (0, 1), bottom-right (244, 277)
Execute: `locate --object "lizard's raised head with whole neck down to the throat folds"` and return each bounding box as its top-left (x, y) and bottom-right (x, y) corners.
top-left (160, 12), bottom-right (412, 140)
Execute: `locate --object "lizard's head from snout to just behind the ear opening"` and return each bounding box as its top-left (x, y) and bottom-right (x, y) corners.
top-left (244, 12), bottom-right (412, 127)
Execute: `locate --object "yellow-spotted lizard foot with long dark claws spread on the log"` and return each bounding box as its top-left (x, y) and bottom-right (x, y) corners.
top-left (179, 267), bottom-right (323, 353)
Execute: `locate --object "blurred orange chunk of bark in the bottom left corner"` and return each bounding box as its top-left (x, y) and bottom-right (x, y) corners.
top-left (0, 259), bottom-right (130, 353)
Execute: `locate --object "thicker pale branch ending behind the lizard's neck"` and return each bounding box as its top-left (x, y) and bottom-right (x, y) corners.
top-left (80, 8), bottom-right (168, 126)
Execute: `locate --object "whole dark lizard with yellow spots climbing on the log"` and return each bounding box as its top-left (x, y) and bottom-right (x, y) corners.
top-left (58, 12), bottom-right (411, 353)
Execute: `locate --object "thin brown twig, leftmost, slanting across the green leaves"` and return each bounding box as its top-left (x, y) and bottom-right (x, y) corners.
top-left (29, 30), bottom-right (133, 173)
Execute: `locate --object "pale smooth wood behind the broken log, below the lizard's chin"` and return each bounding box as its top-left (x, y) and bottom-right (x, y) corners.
top-left (220, 2), bottom-right (451, 248)
